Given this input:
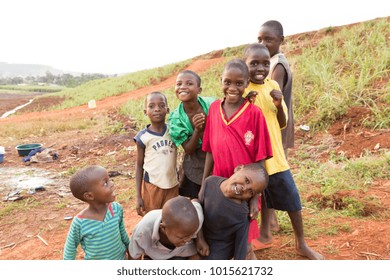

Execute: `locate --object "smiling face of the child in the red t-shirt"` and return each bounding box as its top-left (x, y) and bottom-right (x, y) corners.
top-left (221, 67), bottom-right (249, 104)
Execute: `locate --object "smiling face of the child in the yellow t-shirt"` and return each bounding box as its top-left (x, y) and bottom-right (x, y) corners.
top-left (245, 49), bottom-right (270, 84)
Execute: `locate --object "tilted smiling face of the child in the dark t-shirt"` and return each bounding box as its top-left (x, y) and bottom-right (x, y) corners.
top-left (227, 168), bottom-right (267, 201)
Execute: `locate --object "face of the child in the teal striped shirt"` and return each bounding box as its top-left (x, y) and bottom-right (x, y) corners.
top-left (88, 168), bottom-right (116, 203)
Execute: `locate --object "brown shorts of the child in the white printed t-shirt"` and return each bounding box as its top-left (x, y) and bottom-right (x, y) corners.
top-left (141, 181), bottom-right (179, 214)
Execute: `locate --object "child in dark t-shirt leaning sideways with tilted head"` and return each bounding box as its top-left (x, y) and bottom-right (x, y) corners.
top-left (199, 163), bottom-right (268, 260)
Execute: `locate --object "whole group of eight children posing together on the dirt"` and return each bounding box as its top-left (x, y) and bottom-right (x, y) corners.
top-left (64, 21), bottom-right (324, 260)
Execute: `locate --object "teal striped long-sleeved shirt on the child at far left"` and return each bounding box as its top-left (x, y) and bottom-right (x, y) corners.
top-left (64, 202), bottom-right (130, 260)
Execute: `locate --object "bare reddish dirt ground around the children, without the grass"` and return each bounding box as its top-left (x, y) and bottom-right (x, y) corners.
top-left (0, 58), bottom-right (390, 260)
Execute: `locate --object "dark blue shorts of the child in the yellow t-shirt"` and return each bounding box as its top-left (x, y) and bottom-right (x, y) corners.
top-left (264, 170), bottom-right (302, 212)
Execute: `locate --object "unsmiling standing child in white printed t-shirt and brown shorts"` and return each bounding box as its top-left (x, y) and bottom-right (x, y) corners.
top-left (134, 92), bottom-right (179, 216)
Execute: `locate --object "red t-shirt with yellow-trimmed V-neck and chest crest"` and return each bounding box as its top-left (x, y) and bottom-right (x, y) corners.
top-left (202, 100), bottom-right (272, 178)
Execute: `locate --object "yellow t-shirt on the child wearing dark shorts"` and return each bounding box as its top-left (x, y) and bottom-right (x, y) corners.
top-left (244, 78), bottom-right (290, 175)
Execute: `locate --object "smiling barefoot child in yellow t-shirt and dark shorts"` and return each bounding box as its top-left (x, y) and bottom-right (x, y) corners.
top-left (244, 43), bottom-right (324, 259)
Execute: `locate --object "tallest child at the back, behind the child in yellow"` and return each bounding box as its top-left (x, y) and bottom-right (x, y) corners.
top-left (257, 20), bottom-right (294, 231)
